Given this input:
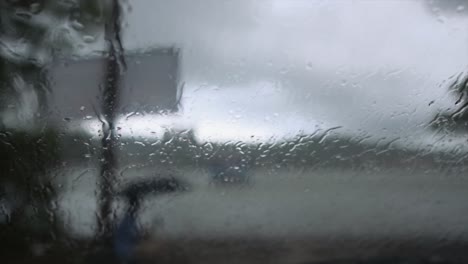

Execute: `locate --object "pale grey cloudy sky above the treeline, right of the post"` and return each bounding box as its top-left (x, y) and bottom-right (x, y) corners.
top-left (115, 0), bottom-right (468, 145)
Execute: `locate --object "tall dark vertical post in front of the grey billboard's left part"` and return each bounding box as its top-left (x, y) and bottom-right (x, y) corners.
top-left (98, 0), bottom-right (125, 239)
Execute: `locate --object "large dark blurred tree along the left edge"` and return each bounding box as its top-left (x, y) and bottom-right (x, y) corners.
top-left (0, 0), bottom-right (119, 254)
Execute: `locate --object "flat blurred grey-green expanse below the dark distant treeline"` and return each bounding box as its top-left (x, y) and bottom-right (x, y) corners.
top-left (60, 167), bottom-right (468, 240)
